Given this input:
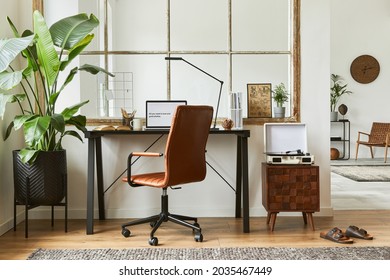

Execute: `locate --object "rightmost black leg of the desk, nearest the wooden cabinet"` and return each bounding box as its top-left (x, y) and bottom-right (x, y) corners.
top-left (241, 137), bottom-right (249, 233)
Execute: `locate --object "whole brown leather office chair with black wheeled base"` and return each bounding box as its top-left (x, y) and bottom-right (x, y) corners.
top-left (122, 105), bottom-right (213, 246)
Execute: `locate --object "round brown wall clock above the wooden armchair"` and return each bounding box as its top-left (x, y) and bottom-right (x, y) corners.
top-left (351, 55), bottom-right (380, 84)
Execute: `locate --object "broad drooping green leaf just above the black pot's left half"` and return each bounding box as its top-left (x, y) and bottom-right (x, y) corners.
top-left (23, 116), bottom-right (51, 147)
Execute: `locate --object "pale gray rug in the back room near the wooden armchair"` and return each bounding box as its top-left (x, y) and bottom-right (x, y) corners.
top-left (331, 165), bottom-right (390, 182)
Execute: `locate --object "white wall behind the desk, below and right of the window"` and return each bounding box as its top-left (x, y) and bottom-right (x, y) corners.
top-left (0, 0), bottom-right (338, 236)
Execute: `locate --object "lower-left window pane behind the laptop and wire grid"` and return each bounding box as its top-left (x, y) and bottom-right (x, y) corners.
top-left (81, 55), bottom-right (167, 117)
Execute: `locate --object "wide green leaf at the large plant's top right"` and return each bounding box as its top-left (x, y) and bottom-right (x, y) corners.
top-left (50, 13), bottom-right (99, 50)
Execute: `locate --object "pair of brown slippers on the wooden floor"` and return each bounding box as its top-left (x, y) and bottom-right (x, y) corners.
top-left (320, 226), bottom-right (374, 244)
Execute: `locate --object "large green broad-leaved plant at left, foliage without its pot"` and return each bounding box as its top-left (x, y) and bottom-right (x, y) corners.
top-left (0, 11), bottom-right (112, 163)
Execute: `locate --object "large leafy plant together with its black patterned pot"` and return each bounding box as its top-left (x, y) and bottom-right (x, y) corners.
top-left (0, 11), bottom-right (111, 210)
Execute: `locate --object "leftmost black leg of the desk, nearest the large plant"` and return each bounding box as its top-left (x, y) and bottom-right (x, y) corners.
top-left (87, 138), bottom-right (95, 234)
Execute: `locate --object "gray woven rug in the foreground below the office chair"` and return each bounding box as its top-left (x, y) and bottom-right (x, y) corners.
top-left (28, 246), bottom-right (390, 260)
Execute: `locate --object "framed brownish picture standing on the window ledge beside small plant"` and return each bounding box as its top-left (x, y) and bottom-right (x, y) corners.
top-left (247, 83), bottom-right (272, 118)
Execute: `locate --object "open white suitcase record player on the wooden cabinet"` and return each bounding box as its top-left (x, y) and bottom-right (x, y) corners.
top-left (264, 123), bottom-right (314, 164)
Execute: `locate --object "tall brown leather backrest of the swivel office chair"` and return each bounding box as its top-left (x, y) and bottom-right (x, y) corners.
top-left (165, 105), bottom-right (213, 186)
